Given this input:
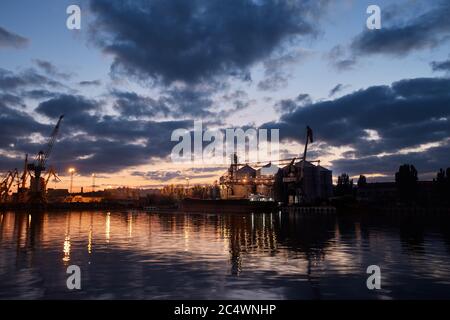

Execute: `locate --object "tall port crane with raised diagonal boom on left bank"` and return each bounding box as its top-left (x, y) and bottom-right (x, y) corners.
top-left (27, 115), bottom-right (64, 203)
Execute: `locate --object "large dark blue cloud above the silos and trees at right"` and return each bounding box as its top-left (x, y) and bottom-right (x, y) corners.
top-left (264, 78), bottom-right (450, 178)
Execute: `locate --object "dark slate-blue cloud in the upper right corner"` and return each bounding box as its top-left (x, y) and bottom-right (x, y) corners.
top-left (351, 0), bottom-right (450, 56)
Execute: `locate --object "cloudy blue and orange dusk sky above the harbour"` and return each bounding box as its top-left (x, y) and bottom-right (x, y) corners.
top-left (0, 0), bottom-right (450, 190)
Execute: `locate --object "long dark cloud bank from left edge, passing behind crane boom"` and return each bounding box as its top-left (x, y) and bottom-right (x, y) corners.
top-left (0, 90), bottom-right (192, 174)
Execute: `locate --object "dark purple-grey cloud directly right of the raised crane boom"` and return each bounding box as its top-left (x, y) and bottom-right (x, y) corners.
top-left (53, 117), bottom-right (192, 174)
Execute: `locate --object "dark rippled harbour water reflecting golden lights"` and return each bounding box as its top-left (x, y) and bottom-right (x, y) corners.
top-left (0, 212), bottom-right (450, 299)
